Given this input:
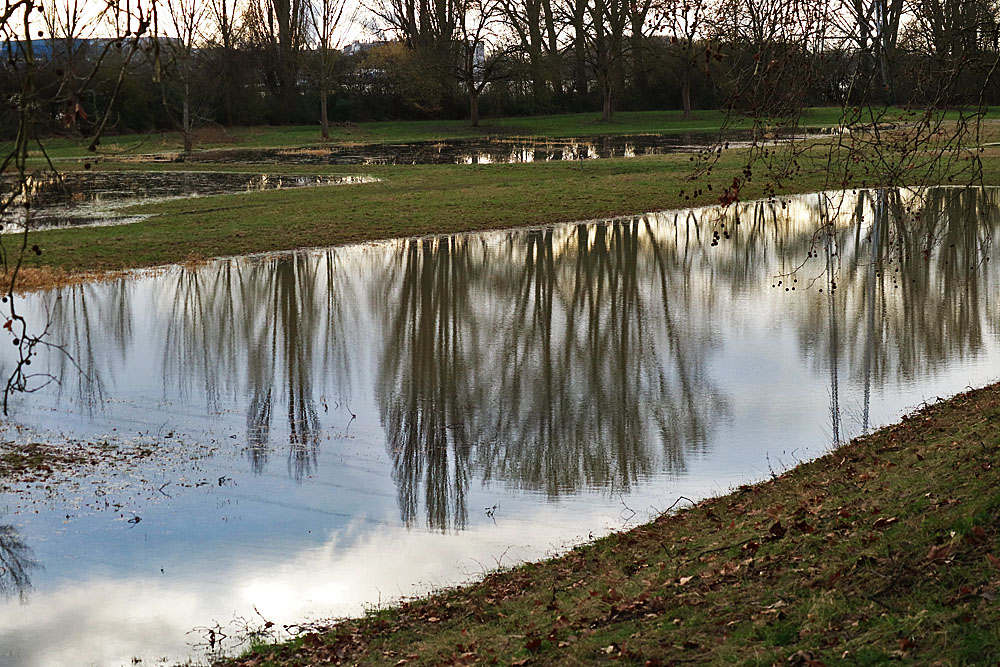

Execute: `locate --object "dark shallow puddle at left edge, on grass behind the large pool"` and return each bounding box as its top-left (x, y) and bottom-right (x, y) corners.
top-left (0, 171), bottom-right (377, 233)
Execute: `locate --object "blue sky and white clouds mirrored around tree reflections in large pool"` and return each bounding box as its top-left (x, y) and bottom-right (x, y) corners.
top-left (0, 189), bottom-right (998, 665)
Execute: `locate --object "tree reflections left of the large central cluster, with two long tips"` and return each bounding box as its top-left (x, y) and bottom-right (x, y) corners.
top-left (164, 251), bottom-right (336, 480)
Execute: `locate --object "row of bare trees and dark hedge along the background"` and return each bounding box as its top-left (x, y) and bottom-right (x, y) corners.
top-left (0, 0), bottom-right (1000, 141)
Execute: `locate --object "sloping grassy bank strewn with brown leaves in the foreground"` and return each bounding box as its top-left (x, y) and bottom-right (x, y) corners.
top-left (223, 386), bottom-right (1000, 667)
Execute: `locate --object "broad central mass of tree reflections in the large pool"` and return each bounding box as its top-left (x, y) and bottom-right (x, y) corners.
top-left (376, 224), bottom-right (725, 529)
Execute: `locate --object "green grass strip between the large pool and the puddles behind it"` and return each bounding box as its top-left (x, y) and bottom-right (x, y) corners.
top-left (11, 144), bottom-right (1000, 286)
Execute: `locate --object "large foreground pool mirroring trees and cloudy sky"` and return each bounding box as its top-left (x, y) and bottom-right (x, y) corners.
top-left (0, 189), bottom-right (1000, 666)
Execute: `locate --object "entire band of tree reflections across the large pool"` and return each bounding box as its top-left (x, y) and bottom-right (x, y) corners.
top-left (27, 188), bottom-right (1000, 530)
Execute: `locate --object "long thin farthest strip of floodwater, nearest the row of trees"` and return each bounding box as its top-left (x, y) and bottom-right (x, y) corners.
top-left (121, 130), bottom-right (820, 165)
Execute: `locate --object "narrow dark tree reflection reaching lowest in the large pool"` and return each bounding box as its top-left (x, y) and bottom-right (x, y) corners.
top-left (375, 237), bottom-right (484, 528)
